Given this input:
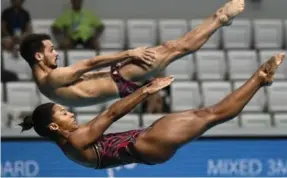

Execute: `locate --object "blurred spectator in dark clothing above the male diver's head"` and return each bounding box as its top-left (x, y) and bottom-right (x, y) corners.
top-left (1, 0), bottom-right (32, 56)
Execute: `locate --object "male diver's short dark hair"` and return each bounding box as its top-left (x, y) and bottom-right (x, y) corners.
top-left (20, 34), bottom-right (51, 66)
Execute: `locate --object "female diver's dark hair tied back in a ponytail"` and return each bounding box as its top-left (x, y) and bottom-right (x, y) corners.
top-left (19, 103), bottom-right (58, 141)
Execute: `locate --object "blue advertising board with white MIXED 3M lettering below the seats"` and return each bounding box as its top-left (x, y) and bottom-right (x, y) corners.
top-left (1, 138), bottom-right (287, 177)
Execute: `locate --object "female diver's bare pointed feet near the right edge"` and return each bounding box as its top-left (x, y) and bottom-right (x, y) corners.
top-left (258, 53), bottom-right (285, 86)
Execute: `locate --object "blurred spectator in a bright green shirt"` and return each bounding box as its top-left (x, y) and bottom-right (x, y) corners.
top-left (52, 0), bottom-right (104, 50)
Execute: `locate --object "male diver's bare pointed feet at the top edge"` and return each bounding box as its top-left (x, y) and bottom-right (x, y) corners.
top-left (216, 0), bottom-right (245, 26)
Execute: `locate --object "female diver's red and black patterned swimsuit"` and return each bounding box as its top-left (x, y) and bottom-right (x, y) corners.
top-left (93, 129), bottom-right (152, 169)
